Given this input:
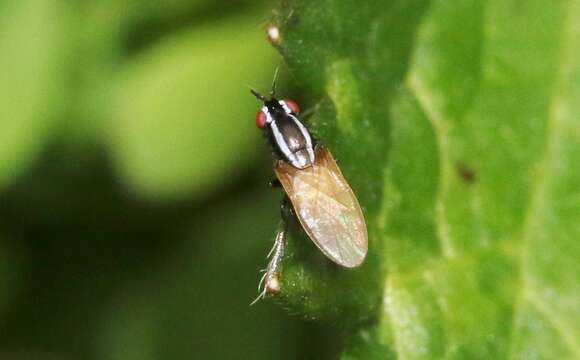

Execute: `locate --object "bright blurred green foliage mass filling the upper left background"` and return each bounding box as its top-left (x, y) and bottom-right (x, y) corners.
top-left (0, 0), bottom-right (275, 200)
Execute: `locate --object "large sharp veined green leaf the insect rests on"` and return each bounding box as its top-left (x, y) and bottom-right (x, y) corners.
top-left (275, 0), bottom-right (580, 359)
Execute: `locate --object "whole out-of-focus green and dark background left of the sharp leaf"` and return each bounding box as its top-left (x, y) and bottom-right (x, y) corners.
top-left (0, 0), bottom-right (339, 360)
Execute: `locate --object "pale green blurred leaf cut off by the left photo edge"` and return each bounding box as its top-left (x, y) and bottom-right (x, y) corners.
top-left (0, 0), bottom-right (67, 188)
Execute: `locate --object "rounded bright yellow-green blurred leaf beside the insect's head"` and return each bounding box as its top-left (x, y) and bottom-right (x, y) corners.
top-left (110, 16), bottom-right (274, 198)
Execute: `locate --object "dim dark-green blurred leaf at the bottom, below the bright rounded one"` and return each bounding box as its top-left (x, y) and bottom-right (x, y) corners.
top-left (100, 195), bottom-right (318, 360)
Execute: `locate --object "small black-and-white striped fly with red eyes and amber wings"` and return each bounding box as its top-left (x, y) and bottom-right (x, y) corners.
top-left (251, 73), bottom-right (368, 304)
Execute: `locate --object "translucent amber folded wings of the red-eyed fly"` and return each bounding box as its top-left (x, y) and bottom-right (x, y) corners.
top-left (274, 146), bottom-right (368, 268)
